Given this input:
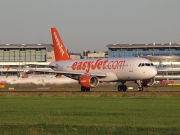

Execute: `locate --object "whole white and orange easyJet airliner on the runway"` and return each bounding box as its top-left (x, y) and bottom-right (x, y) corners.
top-left (49, 28), bottom-right (157, 92)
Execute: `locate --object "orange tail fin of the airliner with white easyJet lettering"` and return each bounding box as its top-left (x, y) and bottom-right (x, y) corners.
top-left (51, 28), bottom-right (71, 61)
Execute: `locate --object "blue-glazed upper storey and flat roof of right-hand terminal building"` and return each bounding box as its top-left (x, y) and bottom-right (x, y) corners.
top-left (107, 43), bottom-right (180, 57)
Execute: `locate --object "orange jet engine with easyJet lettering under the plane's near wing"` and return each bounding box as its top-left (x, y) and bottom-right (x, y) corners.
top-left (79, 76), bottom-right (99, 88)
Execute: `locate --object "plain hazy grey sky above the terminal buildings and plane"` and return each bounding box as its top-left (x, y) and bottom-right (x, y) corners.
top-left (0, 0), bottom-right (180, 53)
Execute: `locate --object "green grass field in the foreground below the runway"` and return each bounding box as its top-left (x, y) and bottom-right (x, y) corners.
top-left (0, 93), bottom-right (180, 135)
